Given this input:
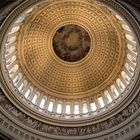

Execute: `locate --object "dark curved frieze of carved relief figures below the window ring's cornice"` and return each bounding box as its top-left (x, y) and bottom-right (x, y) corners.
top-left (0, 91), bottom-right (140, 136)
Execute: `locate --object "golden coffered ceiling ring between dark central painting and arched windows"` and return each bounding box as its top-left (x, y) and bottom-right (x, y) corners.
top-left (18, 1), bottom-right (125, 98)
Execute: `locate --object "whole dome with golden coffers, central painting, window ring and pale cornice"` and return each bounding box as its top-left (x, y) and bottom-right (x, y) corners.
top-left (1, 0), bottom-right (139, 140)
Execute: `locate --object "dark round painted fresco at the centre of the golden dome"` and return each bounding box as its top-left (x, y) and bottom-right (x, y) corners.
top-left (53, 24), bottom-right (91, 62)
